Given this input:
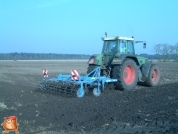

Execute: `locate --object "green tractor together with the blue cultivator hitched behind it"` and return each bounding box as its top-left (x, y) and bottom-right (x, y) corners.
top-left (39, 33), bottom-right (160, 98)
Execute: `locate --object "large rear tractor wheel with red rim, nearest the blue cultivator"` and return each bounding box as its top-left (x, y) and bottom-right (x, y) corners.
top-left (112, 58), bottom-right (138, 90)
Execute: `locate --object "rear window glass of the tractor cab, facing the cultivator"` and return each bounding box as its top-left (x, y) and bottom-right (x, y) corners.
top-left (102, 40), bottom-right (118, 54)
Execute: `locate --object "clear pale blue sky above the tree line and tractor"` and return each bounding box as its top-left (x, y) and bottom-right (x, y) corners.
top-left (0, 0), bottom-right (178, 54)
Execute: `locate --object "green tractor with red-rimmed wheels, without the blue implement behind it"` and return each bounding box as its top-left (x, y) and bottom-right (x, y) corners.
top-left (87, 33), bottom-right (160, 90)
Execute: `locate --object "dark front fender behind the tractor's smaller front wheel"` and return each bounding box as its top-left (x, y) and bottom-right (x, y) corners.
top-left (140, 61), bottom-right (153, 78)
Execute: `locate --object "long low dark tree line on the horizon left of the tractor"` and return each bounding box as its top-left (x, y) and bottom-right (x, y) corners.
top-left (0, 52), bottom-right (90, 60)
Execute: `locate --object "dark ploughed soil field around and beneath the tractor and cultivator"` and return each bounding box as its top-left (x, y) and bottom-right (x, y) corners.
top-left (0, 60), bottom-right (178, 134)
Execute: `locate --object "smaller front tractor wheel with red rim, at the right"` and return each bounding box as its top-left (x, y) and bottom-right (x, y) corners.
top-left (145, 64), bottom-right (160, 87)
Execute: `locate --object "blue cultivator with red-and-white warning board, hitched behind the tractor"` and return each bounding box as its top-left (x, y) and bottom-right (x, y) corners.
top-left (39, 67), bottom-right (117, 98)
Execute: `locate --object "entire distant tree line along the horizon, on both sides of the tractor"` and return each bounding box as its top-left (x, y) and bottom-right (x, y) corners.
top-left (0, 43), bottom-right (178, 62)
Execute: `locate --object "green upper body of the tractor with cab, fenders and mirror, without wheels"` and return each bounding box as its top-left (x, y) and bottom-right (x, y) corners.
top-left (88, 36), bottom-right (147, 68)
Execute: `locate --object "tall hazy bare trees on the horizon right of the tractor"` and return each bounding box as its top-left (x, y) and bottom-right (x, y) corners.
top-left (153, 43), bottom-right (178, 62)
